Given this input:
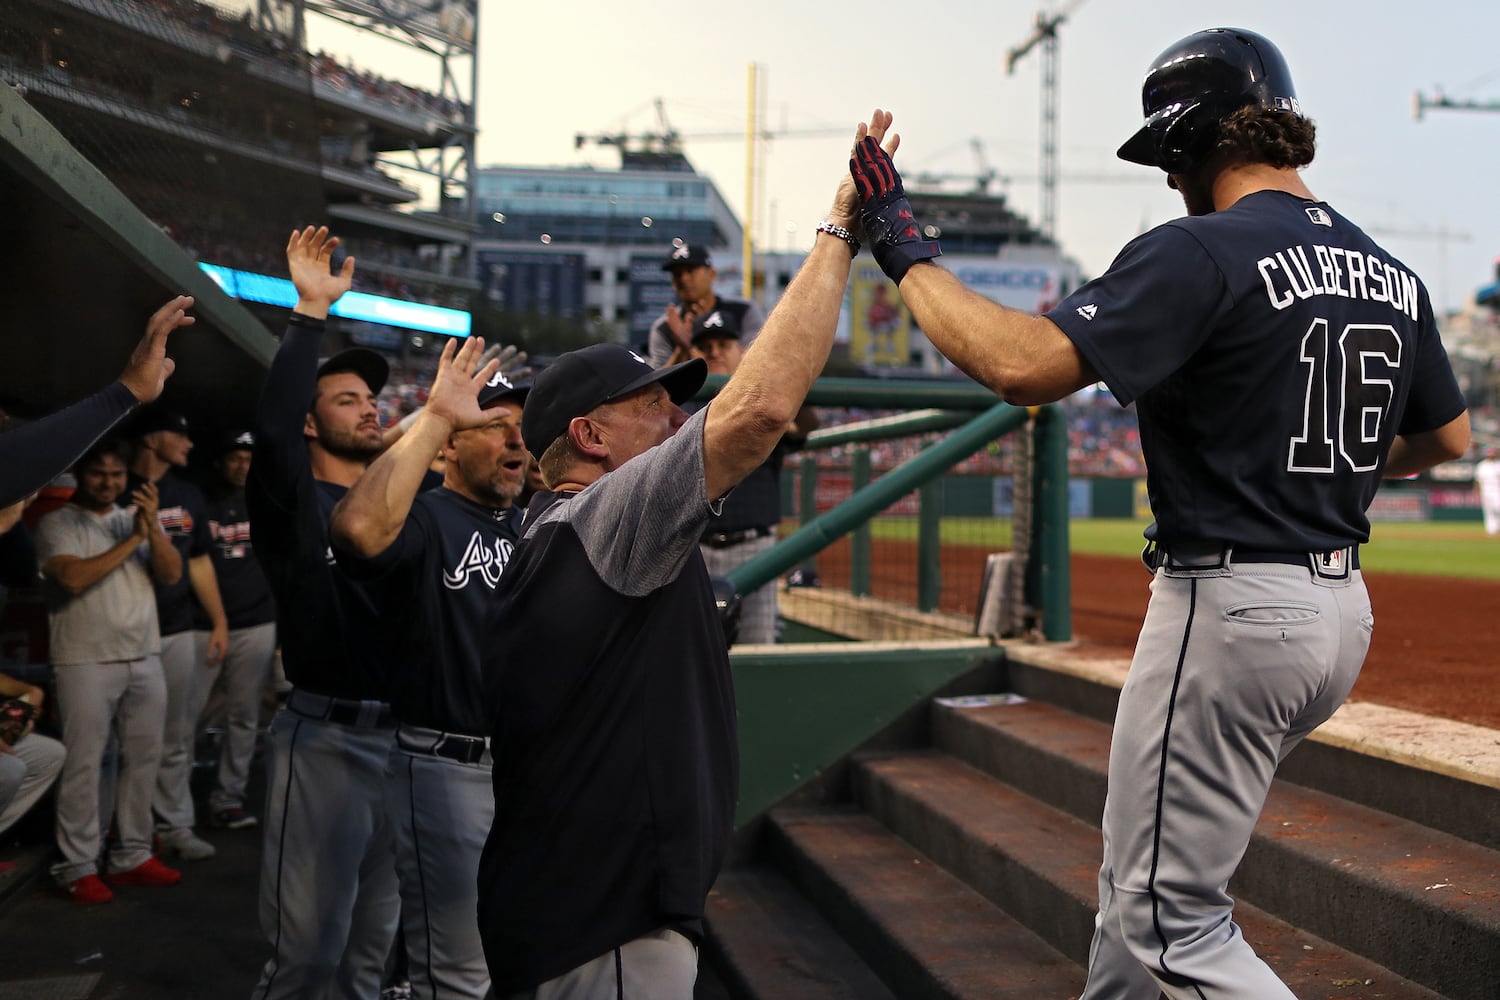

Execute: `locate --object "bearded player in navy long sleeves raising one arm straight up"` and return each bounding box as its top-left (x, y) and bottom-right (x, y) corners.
top-left (245, 226), bottom-right (401, 1000)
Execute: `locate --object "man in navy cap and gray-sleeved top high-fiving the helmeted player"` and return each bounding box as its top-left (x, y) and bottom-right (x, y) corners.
top-left (479, 118), bottom-right (894, 1000)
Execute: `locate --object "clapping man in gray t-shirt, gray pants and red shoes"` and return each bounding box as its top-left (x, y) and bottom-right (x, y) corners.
top-left (36, 442), bottom-right (183, 906)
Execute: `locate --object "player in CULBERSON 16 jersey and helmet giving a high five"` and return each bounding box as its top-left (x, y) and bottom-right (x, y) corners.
top-left (851, 28), bottom-right (1469, 1000)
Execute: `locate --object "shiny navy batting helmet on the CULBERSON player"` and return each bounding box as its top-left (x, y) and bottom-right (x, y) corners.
top-left (1119, 28), bottom-right (1302, 174)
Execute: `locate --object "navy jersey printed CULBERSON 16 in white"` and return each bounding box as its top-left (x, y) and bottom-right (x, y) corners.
top-left (1047, 190), bottom-right (1464, 552)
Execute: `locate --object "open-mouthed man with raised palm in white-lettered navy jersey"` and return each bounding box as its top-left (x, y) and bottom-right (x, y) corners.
top-left (330, 339), bottom-right (528, 1000)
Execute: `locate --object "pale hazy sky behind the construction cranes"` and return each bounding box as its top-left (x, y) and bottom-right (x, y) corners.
top-left (304, 0), bottom-right (1500, 309)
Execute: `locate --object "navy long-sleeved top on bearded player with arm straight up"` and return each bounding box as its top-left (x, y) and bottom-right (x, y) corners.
top-left (245, 313), bottom-right (389, 700)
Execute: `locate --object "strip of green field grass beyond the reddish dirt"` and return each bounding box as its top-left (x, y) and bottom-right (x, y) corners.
top-left (872, 517), bottom-right (1500, 580)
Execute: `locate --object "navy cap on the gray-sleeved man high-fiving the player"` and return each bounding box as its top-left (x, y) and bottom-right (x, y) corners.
top-left (521, 343), bottom-right (708, 459)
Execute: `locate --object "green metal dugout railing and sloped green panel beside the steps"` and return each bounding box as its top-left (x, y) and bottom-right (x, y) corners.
top-left (687, 376), bottom-right (1073, 826)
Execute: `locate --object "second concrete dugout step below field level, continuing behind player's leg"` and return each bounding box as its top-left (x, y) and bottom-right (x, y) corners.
top-left (854, 751), bottom-right (1452, 1000)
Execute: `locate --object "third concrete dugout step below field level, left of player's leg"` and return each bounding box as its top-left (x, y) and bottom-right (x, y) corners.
top-left (768, 807), bottom-right (1083, 1000)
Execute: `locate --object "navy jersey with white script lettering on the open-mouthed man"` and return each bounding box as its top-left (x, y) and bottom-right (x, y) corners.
top-left (335, 487), bottom-right (522, 736)
